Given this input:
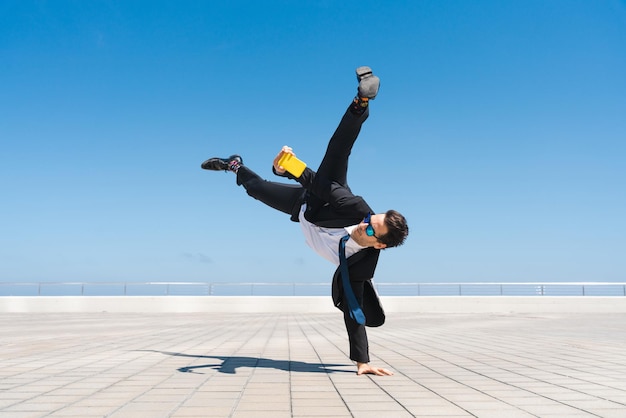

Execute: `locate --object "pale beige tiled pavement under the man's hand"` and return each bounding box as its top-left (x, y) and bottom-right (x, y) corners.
top-left (0, 312), bottom-right (626, 418)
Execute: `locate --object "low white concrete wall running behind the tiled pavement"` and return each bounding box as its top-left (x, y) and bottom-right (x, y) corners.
top-left (0, 296), bottom-right (626, 313)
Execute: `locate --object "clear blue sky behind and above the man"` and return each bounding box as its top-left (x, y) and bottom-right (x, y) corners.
top-left (0, 0), bottom-right (626, 283)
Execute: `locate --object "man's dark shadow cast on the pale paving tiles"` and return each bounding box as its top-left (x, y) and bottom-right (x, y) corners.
top-left (138, 350), bottom-right (355, 374)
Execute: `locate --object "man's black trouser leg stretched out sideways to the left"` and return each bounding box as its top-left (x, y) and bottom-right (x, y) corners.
top-left (237, 166), bottom-right (304, 215)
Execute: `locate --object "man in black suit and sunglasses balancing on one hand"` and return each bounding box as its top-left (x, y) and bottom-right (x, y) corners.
top-left (202, 67), bottom-right (409, 376)
